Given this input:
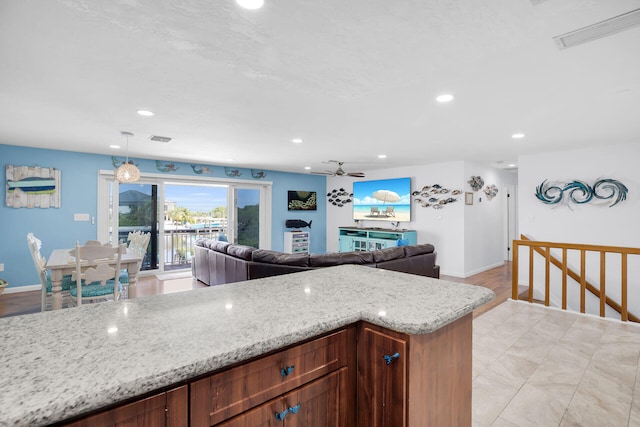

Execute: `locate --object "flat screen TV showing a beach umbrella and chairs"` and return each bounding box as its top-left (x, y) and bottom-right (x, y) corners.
top-left (353, 178), bottom-right (411, 222)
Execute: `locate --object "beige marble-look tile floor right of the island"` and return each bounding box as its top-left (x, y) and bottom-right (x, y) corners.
top-left (473, 301), bottom-right (640, 427)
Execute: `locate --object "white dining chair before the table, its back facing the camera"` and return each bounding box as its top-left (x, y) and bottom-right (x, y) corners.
top-left (69, 242), bottom-right (127, 306)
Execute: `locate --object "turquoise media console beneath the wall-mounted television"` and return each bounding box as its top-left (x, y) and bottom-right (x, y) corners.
top-left (338, 227), bottom-right (417, 252)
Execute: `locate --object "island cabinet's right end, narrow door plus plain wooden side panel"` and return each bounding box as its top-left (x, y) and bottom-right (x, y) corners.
top-left (357, 314), bottom-right (472, 427)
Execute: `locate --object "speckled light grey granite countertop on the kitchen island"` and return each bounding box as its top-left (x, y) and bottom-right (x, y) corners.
top-left (0, 265), bottom-right (494, 426)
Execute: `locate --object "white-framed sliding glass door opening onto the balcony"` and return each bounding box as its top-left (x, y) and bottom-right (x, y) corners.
top-left (97, 171), bottom-right (271, 272)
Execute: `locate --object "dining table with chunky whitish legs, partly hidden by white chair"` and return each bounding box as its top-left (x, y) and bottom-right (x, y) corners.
top-left (46, 249), bottom-right (142, 310)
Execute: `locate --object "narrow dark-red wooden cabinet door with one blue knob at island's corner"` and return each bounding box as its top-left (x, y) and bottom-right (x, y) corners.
top-left (358, 324), bottom-right (408, 427)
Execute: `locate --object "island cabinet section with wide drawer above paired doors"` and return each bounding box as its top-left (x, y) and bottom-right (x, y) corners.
top-left (190, 327), bottom-right (355, 427)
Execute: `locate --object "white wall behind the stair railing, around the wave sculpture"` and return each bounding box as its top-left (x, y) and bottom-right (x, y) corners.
top-left (518, 143), bottom-right (640, 315)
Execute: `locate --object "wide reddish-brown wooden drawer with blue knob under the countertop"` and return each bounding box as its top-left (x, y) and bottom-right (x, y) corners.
top-left (190, 330), bottom-right (352, 426)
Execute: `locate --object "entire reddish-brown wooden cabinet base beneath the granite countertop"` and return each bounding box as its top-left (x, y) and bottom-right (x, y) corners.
top-left (56, 313), bottom-right (472, 427)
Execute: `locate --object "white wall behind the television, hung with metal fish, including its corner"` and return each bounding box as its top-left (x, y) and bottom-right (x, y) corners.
top-left (327, 161), bottom-right (515, 277)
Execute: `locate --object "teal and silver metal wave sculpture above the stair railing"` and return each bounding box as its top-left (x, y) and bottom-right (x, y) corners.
top-left (536, 178), bottom-right (629, 208)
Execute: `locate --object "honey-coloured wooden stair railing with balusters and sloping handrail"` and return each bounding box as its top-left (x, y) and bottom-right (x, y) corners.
top-left (511, 234), bottom-right (640, 322)
